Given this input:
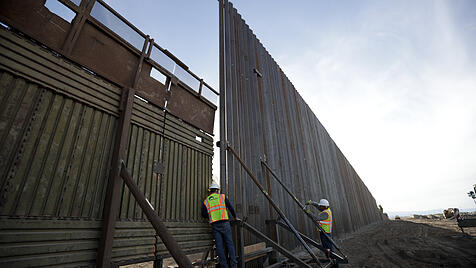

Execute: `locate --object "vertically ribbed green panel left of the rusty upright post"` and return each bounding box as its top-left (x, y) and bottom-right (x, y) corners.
top-left (0, 72), bottom-right (116, 218)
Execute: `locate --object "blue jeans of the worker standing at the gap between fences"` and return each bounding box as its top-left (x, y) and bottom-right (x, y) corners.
top-left (212, 221), bottom-right (238, 268)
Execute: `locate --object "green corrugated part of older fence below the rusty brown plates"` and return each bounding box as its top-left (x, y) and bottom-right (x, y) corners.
top-left (0, 16), bottom-right (213, 267)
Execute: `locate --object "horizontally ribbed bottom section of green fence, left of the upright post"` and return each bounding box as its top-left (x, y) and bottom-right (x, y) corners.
top-left (0, 219), bottom-right (101, 267)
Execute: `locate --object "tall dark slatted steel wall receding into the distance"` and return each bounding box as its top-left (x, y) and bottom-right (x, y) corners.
top-left (220, 1), bottom-right (382, 248)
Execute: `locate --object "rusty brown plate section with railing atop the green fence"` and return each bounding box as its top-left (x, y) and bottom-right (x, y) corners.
top-left (0, 0), bottom-right (218, 134)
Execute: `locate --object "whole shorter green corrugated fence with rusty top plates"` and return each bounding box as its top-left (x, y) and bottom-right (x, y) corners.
top-left (0, 0), bottom-right (218, 267)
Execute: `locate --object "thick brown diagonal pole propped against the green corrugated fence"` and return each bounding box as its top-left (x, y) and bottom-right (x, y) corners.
top-left (121, 161), bottom-right (193, 267)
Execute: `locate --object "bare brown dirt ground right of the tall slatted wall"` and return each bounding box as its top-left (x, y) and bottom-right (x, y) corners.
top-left (340, 218), bottom-right (476, 267)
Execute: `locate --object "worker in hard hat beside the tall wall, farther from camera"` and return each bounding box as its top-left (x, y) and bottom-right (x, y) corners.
top-left (307, 199), bottom-right (333, 258)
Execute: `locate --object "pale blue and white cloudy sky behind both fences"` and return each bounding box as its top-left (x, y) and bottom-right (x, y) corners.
top-left (94, 0), bottom-right (476, 214)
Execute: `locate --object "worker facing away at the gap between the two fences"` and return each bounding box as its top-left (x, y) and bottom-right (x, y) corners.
top-left (202, 182), bottom-right (239, 268)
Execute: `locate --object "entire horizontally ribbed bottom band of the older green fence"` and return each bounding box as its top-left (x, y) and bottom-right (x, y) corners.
top-left (0, 219), bottom-right (213, 267)
